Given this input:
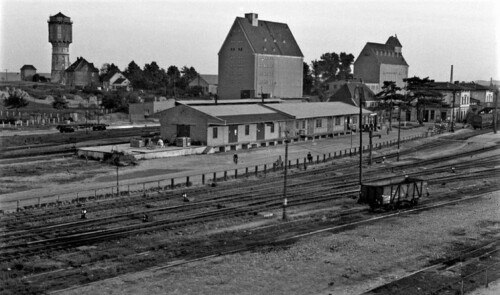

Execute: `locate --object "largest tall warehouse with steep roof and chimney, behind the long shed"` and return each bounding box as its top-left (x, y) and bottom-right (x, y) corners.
top-left (218, 13), bottom-right (304, 99)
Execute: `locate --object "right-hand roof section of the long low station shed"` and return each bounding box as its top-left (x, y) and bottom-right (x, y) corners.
top-left (265, 102), bottom-right (371, 119)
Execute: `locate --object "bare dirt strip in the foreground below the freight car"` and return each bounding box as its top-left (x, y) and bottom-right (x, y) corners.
top-left (62, 192), bottom-right (500, 295)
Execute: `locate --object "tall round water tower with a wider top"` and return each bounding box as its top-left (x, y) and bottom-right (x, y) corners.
top-left (48, 12), bottom-right (73, 83)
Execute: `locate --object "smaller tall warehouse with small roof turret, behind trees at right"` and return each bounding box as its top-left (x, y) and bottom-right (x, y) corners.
top-left (353, 35), bottom-right (409, 93)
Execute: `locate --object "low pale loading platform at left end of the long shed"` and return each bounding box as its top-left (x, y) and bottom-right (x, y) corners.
top-left (77, 143), bottom-right (213, 160)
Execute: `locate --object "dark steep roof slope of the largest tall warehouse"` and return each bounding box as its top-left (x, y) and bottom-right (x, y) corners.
top-left (236, 17), bottom-right (304, 57)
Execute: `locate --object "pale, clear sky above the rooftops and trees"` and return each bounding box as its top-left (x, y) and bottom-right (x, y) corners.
top-left (0, 0), bottom-right (500, 81)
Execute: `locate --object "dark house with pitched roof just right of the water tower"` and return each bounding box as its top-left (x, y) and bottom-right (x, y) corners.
top-left (63, 57), bottom-right (100, 87)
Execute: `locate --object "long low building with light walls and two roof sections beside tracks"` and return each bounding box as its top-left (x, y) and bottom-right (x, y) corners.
top-left (159, 102), bottom-right (371, 152)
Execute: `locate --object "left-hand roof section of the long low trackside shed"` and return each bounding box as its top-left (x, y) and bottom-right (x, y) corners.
top-left (189, 104), bottom-right (291, 125)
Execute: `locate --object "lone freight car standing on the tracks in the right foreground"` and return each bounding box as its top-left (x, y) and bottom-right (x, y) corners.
top-left (359, 176), bottom-right (427, 211)
